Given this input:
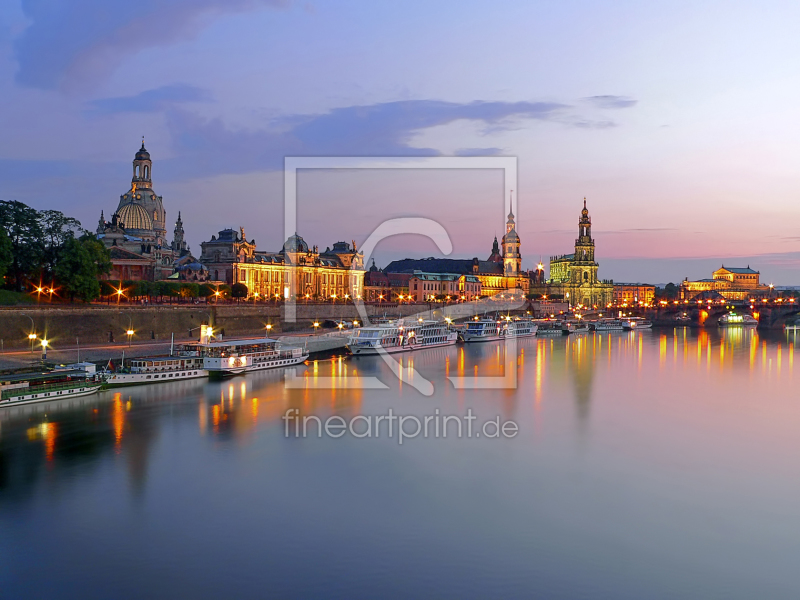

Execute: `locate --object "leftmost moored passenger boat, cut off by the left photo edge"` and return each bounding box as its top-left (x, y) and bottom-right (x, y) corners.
top-left (0, 370), bottom-right (103, 408)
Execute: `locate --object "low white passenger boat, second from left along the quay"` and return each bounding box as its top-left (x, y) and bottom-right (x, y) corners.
top-left (106, 344), bottom-right (208, 387)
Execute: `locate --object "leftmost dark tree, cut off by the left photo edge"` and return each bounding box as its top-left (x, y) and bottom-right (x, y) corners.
top-left (0, 200), bottom-right (44, 292)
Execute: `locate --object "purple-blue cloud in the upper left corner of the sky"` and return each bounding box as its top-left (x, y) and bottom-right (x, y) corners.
top-left (14, 0), bottom-right (288, 89)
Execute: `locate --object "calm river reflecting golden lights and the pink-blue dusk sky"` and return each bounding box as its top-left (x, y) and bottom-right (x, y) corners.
top-left (0, 329), bottom-right (800, 600)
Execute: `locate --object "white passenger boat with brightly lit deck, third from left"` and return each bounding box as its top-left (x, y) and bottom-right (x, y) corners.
top-left (202, 338), bottom-right (308, 376)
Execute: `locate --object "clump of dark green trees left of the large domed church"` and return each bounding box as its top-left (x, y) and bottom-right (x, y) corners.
top-left (0, 200), bottom-right (111, 302)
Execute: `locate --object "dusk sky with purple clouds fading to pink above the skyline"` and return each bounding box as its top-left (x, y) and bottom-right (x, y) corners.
top-left (0, 0), bottom-right (800, 285)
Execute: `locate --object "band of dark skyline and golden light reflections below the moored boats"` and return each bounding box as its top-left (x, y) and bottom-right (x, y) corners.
top-left (0, 328), bottom-right (795, 504)
